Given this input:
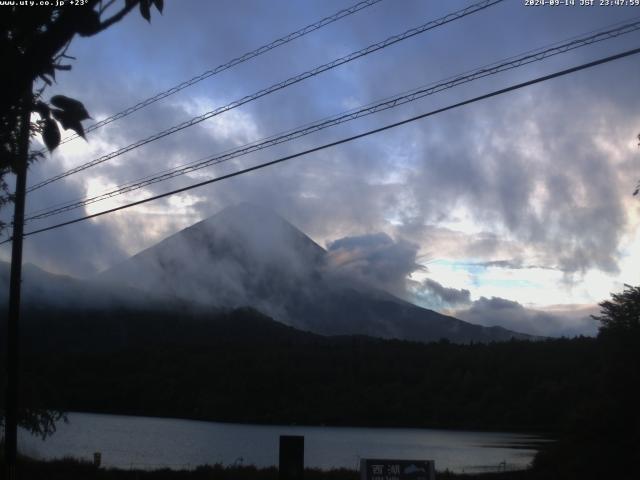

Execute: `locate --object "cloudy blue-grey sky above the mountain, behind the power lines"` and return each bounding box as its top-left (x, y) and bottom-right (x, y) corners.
top-left (0, 0), bottom-right (640, 336)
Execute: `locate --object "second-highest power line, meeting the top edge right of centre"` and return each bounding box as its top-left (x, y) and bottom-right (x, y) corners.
top-left (27, 0), bottom-right (504, 192)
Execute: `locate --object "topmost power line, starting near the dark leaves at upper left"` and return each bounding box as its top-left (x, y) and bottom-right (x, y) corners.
top-left (41, 0), bottom-right (390, 150)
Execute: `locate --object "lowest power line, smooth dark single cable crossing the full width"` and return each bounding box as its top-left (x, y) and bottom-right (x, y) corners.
top-left (0, 48), bottom-right (640, 245)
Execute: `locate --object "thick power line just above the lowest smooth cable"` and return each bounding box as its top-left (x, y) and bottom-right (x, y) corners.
top-left (26, 17), bottom-right (640, 221)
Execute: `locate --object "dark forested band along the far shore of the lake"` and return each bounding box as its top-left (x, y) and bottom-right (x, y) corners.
top-left (7, 309), bottom-right (600, 431)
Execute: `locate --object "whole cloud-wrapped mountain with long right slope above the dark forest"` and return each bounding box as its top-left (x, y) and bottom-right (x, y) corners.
top-left (96, 204), bottom-right (531, 342)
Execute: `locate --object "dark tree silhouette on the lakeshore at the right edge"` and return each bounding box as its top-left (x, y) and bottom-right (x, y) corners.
top-left (535, 285), bottom-right (640, 480)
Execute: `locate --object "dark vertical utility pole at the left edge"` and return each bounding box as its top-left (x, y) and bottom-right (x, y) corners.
top-left (4, 83), bottom-right (32, 480)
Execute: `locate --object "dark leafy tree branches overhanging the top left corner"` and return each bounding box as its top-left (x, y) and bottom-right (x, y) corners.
top-left (0, 0), bottom-right (163, 446)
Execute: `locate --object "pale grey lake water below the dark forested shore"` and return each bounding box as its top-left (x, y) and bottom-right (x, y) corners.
top-left (19, 413), bottom-right (541, 472)
